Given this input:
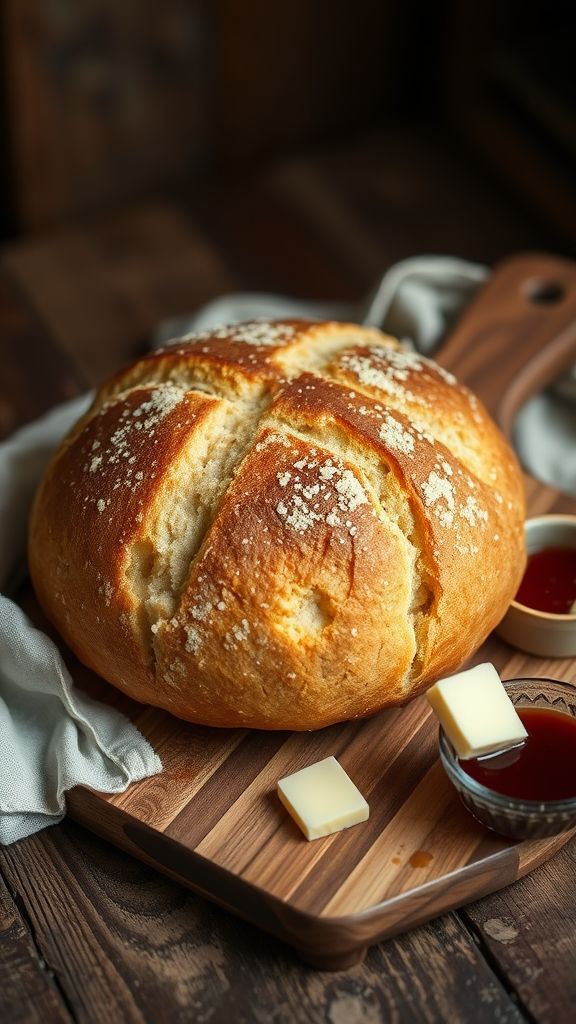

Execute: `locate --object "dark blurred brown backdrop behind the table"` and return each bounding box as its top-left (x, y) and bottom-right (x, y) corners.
top-left (0, 0), bottom-right (576, 258)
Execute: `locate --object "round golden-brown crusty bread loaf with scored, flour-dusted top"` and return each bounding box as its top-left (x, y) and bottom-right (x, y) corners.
top-left (30, 319), bottom-right (525, 729)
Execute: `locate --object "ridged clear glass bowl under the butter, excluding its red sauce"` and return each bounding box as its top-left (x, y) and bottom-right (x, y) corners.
top-left (439, 679), bottom-right (576, 839)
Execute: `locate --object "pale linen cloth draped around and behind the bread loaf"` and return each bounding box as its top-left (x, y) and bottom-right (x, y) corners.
top-left (0, 256), bottom-right (576, 844)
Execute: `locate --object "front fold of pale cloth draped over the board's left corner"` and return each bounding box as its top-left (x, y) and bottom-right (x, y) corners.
top-left (0, 595), bottom-right (162, 844)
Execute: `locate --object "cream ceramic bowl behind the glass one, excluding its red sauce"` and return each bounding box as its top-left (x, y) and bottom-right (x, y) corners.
top-left (496, 515), bottom-right (576, 657)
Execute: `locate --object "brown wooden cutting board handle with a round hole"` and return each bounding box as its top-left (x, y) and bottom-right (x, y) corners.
top-left (437, 253), bottom-right (576, 436)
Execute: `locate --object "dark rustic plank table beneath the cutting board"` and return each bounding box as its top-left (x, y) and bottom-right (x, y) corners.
top-left (0, 132), bottom-right (576, 1024)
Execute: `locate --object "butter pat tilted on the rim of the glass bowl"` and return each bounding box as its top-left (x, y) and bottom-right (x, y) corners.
top-left (426, 663), bottom-right (528, 759)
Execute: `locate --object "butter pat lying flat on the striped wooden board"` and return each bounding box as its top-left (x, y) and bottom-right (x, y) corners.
top-left (278, 757), bottom-right (370, 839)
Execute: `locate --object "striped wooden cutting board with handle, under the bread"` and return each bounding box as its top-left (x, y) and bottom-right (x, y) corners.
top-left (59, 249), bottom-right (576, 969)
